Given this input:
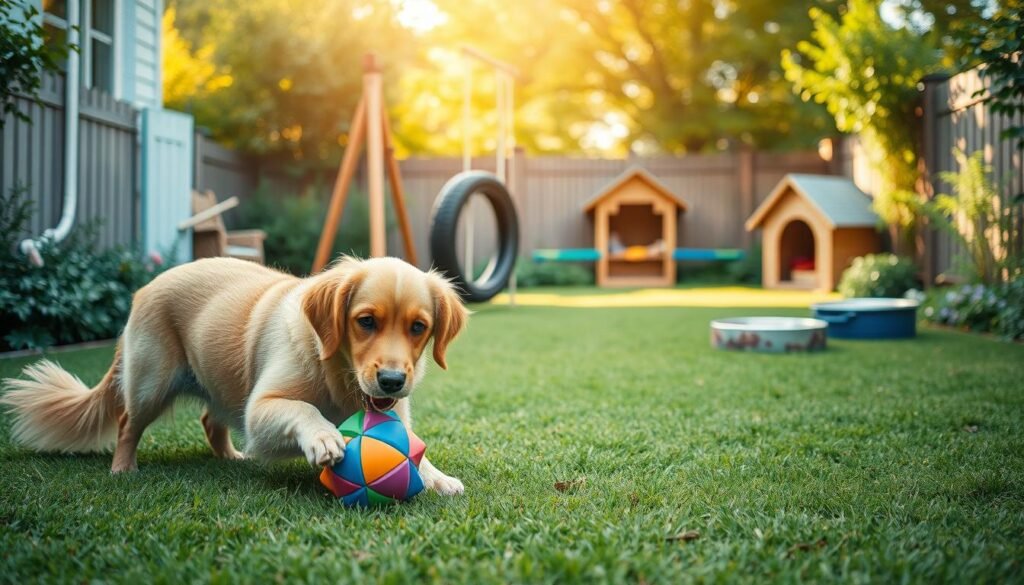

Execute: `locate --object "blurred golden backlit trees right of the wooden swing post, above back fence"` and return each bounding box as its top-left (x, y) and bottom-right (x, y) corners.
top-left (391, 0), bottom-right (838, 154)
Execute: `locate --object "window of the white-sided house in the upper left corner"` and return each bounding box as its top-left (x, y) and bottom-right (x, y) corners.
top-left (43, 0), bottom-right (117, 93)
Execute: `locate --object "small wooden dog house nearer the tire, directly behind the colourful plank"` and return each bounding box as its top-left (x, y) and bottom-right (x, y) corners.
top-left (584, 168), bottom-right (686, 287)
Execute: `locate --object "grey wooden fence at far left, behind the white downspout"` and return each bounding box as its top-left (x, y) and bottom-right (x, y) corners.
top-left (0, 76), bottom-right (138, 247)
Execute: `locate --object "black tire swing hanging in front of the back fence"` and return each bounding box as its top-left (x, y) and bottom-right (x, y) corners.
top-left (430, 171), bottom-right (519, 302)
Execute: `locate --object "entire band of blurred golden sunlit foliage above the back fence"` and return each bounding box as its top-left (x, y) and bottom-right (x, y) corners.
top-left (168, 0), bottom-right (841, 160)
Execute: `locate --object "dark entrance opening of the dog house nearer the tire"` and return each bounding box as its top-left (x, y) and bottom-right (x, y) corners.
top-left (608, 205), bottom-right (667, 278)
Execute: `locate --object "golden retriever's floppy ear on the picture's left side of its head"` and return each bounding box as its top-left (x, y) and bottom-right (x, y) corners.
top-left (302, 260), bottom-right (362, 361)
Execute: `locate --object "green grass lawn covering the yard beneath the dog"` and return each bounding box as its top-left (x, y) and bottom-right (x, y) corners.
top-left (0, 290), bottom-right (1024, 583)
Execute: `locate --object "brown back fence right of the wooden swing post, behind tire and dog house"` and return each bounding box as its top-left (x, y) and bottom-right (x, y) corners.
top-left (388, 152), bottom-right (834, 266)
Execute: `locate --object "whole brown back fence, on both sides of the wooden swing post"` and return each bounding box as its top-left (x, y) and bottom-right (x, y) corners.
top-left (195, 143), bottom-right (840, 267)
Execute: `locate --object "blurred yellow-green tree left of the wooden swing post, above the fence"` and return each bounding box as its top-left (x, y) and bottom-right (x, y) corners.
top-left (165, 0), bottom-right (413, 168)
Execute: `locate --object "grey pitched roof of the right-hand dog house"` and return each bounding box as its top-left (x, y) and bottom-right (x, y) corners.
top-left (746, 174), bottom-right (879, 232)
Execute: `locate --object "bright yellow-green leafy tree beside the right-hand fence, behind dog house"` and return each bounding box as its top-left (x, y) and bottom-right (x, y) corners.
top-left (782, 0), bottom-right (941, 255)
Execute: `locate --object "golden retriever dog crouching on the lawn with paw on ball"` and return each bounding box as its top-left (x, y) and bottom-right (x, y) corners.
top-left (0, 258), bottom-right (469, 494)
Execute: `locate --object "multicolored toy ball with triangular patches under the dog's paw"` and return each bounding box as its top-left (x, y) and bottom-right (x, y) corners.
top-left (321, 411), bottom-right (427, 506)
